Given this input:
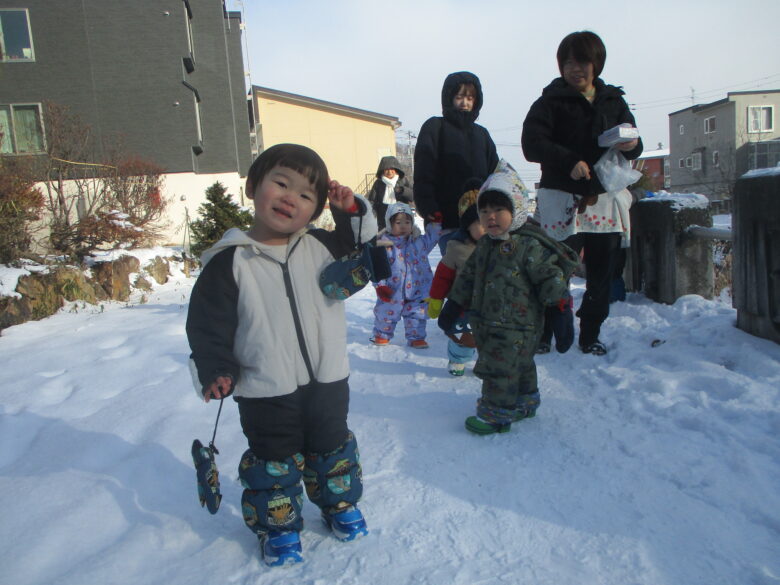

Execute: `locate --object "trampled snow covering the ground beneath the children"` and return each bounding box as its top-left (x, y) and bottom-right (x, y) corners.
top-left (0, 250), bottom-right (780, 585)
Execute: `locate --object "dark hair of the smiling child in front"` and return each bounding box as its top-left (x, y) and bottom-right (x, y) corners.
top-left (246, 144), bottom-right (330, 221)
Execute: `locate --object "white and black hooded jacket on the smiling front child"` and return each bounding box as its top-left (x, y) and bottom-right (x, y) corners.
top-left (187, 195), bottom-right (376, 398)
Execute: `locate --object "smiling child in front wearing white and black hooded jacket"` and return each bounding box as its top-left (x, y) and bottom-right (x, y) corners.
top-left (187, 144), bottom-right (376, 566)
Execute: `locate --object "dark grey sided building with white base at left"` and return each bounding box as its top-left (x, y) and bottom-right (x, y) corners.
top-left (0, 0), bottom-right (252, 244)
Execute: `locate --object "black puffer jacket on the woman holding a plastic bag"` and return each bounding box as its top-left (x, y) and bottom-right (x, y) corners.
top-left (522, 77), bottom-right (642, 196)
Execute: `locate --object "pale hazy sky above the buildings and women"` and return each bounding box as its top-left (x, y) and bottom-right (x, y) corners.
top-left (228, 0), bottom-right (780, 182)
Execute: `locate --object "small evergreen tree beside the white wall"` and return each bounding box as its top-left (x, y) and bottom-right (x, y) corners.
top-left (190, 181), bottom-right (253, 257)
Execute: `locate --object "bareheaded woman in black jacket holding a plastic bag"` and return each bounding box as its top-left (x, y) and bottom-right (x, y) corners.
top-left (522, 31), bottom-right (642, 355)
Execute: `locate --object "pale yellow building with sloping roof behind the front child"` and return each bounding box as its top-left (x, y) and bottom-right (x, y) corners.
top-left (251, 85), bottom-right (401, 192)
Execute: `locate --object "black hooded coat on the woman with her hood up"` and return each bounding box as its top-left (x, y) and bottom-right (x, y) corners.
top-left (414, 71), bottom-right (498, 229)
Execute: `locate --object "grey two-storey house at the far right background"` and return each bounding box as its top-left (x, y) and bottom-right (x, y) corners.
top-left (669, 89), bottom-right (780, 208)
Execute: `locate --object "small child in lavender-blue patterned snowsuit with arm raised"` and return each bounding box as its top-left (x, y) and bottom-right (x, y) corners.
top-left (371, 203), bottom-right (441, 349)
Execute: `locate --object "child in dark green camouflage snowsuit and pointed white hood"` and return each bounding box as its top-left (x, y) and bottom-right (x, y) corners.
top-left (439, 161), bottom-right (578, 434)
